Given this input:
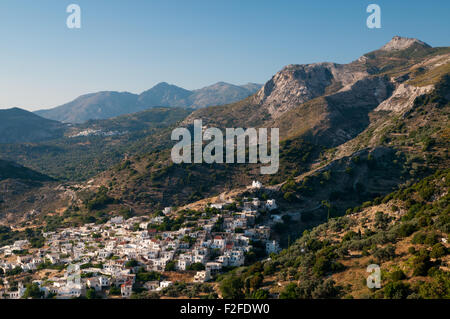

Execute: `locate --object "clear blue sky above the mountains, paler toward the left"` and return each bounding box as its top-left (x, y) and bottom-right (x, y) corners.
top-left (0, 0), bottom-right (450, 110)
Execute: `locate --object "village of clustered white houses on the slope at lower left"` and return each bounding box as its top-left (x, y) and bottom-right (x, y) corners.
top-left (0, 181), bottom-right (283, 299)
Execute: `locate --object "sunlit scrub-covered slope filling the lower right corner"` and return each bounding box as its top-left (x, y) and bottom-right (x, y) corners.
top-left (216, 170), bottom-right (450, 299)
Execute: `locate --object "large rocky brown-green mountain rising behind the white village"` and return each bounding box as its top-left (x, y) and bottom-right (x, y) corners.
top-left (90, 37), bottom-right (450, 213)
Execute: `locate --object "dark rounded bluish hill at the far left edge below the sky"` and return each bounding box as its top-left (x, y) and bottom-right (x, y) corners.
top-left (0, 108), bottom-right (67, 143)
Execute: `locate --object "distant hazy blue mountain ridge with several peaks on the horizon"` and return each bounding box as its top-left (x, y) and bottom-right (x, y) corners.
top-left (35, 82), bottom-right (260, 123)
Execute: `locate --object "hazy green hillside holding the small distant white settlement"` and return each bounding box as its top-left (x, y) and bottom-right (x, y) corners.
top-left (0, 108), bottom-right (191, 181)
